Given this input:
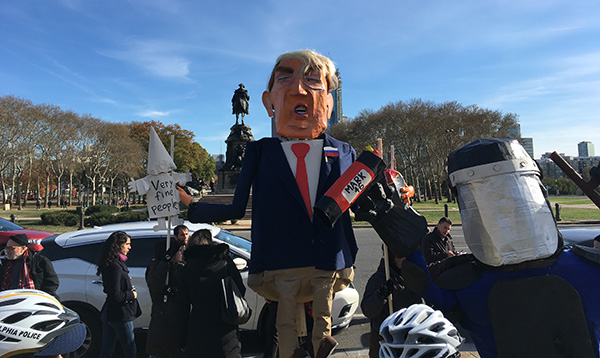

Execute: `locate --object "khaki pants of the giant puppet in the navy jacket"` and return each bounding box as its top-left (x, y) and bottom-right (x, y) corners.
top-left (248, 267), bottom-right (354, 358)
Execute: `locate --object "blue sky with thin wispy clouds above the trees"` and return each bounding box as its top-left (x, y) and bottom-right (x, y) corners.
top-left (0, 0), bottom-right (600, 158)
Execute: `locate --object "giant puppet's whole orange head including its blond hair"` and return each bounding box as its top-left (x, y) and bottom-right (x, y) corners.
top-left (262, 50), bottom-right (338, 139)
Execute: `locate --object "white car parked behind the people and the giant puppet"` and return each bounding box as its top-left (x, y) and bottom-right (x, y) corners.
top-left (41, 221), bottom-right (359, 358)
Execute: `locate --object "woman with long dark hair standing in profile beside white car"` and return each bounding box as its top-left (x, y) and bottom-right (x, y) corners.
top-left (96, 231), bottom-right (142, 358)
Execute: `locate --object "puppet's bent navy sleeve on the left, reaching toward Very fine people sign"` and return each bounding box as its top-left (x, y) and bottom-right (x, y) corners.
top-left (188, 142), bottom-right (259, 223)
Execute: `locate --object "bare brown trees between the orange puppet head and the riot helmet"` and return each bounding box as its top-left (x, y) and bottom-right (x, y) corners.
top-left (329, 99), bottom-right (518, 200)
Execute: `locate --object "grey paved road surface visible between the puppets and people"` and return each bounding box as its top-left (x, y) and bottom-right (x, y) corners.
top-left (236, 225), bottom-right (600, 357)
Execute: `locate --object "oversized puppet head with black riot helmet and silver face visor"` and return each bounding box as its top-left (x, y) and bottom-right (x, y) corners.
top-left (448, 138), bottom-right (559, 266)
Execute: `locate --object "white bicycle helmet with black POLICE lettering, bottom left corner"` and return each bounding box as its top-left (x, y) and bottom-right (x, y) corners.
top-left (0, 289), bottom-right (83, 358)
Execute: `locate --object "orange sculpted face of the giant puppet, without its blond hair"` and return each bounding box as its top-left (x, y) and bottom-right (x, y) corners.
top-left (263, 59), bottom-right (333, 139)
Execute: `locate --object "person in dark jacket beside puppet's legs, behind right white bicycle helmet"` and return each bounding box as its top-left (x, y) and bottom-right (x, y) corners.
top-left (360, 253), bottom-right (422, 358)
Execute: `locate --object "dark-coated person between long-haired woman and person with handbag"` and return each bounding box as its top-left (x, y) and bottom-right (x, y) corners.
top-left (146, 239), bottom-right (183, 358)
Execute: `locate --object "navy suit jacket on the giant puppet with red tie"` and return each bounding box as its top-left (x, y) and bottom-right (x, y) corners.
top-left (188, 134), bottom-right (358, 273)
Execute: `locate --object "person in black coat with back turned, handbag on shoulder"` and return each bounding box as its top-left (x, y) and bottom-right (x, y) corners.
top-left (179, 230), bottom-right (246, 358)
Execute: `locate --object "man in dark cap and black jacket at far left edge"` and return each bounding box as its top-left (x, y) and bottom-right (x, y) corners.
top-left (0, 234), bottom-right (58, 298)
